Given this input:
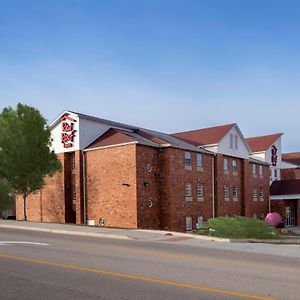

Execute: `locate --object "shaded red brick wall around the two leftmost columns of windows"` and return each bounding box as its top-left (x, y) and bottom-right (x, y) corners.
top-left (160, 148), bottom-right (212, 231)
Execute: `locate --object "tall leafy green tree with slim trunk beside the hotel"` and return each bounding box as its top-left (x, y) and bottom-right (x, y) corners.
top-left (0, 103), bottom-right (61, 220)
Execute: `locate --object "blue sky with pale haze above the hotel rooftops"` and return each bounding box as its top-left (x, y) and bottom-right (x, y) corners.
top-left (0, 0), bottom-right (300, 152)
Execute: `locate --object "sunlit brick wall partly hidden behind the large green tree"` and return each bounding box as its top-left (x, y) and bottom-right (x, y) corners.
top-left (16, 154), bottom-right (65, 223)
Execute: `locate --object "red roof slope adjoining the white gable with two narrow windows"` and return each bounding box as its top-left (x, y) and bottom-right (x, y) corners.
top-left (172, 123), bottom-right (236, 146)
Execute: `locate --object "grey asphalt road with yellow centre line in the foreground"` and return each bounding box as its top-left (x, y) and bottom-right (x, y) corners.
top-left (0, 228), bottom-right (300, 300)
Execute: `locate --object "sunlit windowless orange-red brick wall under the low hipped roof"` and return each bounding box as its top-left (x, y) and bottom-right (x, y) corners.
top-left (85, 145), bottom-right (137, 228)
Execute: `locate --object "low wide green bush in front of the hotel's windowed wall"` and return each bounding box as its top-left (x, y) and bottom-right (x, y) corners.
top-left (198, 217), bottom-right (279, 239)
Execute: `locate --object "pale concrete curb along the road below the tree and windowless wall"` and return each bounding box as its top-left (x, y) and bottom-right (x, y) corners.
top-left (0, 224), bottom-right (132, 240)
